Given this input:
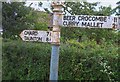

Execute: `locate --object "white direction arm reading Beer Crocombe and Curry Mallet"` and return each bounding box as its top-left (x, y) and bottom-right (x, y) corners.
top-left (59, 15), bottom-right (119, 28)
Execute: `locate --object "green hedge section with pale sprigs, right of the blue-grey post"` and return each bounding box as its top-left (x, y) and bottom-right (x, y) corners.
top-left (59, 40), bottom-right (120, 81)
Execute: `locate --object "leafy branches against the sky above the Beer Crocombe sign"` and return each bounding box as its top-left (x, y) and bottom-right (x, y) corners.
top-left (64, 2), bottom-right (112, 16)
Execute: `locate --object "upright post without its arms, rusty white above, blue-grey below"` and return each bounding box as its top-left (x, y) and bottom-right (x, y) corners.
top-left (50, 2), bottom-right (62, 82)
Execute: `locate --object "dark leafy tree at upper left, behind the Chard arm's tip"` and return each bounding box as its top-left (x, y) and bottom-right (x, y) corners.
top-left (2, 2), bottom-right (37, 38)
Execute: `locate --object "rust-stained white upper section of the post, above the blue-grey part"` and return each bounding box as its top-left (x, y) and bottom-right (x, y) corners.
top-left (52, 2), bottom-right (62, 45)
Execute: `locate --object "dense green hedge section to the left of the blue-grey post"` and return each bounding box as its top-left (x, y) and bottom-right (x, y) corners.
top-left (2, 41), bottom-right (50, 80)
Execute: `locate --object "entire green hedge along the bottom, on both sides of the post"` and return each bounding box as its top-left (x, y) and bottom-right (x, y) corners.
top-left (2, 40), bottom-right (120, 81)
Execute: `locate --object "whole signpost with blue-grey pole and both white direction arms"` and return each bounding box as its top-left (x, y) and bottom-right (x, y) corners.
top-left (20, 0), bottom-right (120, 81)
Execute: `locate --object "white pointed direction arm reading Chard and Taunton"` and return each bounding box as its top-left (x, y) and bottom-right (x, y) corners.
top-left (20, 30), bottom-right (52, 42)
